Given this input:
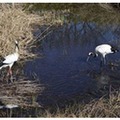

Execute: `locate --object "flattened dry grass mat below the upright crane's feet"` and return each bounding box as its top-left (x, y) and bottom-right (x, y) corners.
top-left (0, 76), bottom-right (44, 107)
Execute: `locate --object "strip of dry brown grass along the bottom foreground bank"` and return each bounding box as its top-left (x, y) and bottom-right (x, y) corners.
top-left (0, 91), bottom-right (120, 118)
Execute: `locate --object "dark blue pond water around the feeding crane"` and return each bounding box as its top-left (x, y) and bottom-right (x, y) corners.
top-left (24, 22), bottom-right (120, 104)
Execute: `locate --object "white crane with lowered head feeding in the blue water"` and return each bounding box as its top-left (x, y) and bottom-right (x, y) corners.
top-left (87, 44), bottom-right (119, 64)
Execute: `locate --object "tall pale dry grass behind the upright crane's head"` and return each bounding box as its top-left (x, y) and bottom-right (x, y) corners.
top-left (0, 4), bottom-right (61, 59)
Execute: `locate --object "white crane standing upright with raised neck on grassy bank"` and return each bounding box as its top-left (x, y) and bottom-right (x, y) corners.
top-left (0, 41), bottom-right (19, 76)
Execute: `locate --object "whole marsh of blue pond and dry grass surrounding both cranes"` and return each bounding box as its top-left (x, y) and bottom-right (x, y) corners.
top-left (0, 3), bottom-right (120, 117)
